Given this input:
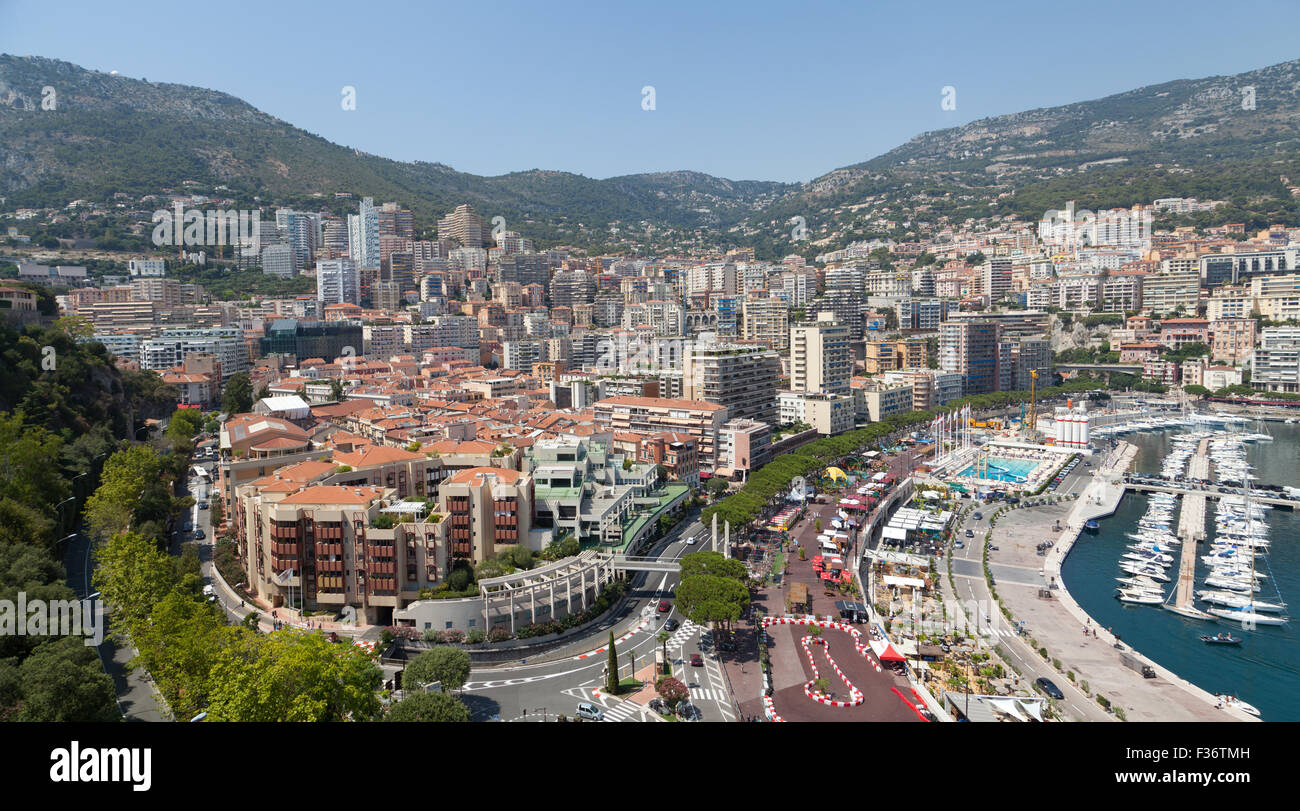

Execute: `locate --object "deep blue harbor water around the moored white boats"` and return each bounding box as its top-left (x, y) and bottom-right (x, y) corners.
top-left (1061, 422), bottom-right (1300, 721)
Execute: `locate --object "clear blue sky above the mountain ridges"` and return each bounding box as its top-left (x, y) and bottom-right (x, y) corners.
top-left (0, 0), bottom-right (1300, 182)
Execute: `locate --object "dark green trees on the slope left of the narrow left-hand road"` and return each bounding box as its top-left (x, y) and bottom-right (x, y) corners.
top-left (0, 317), bottom-right (176, 721)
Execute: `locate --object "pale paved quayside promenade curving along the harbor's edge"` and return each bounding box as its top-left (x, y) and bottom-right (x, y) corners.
top-left (944, 464), bottom-right (1114, 721)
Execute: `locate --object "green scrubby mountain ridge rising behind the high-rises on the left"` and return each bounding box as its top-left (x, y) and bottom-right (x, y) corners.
top-left (0, 55), bottom-right (789, 239)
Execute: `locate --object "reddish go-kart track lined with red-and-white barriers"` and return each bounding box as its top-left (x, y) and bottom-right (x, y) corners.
top-left (763, 616), bottom-right (924, 723)
